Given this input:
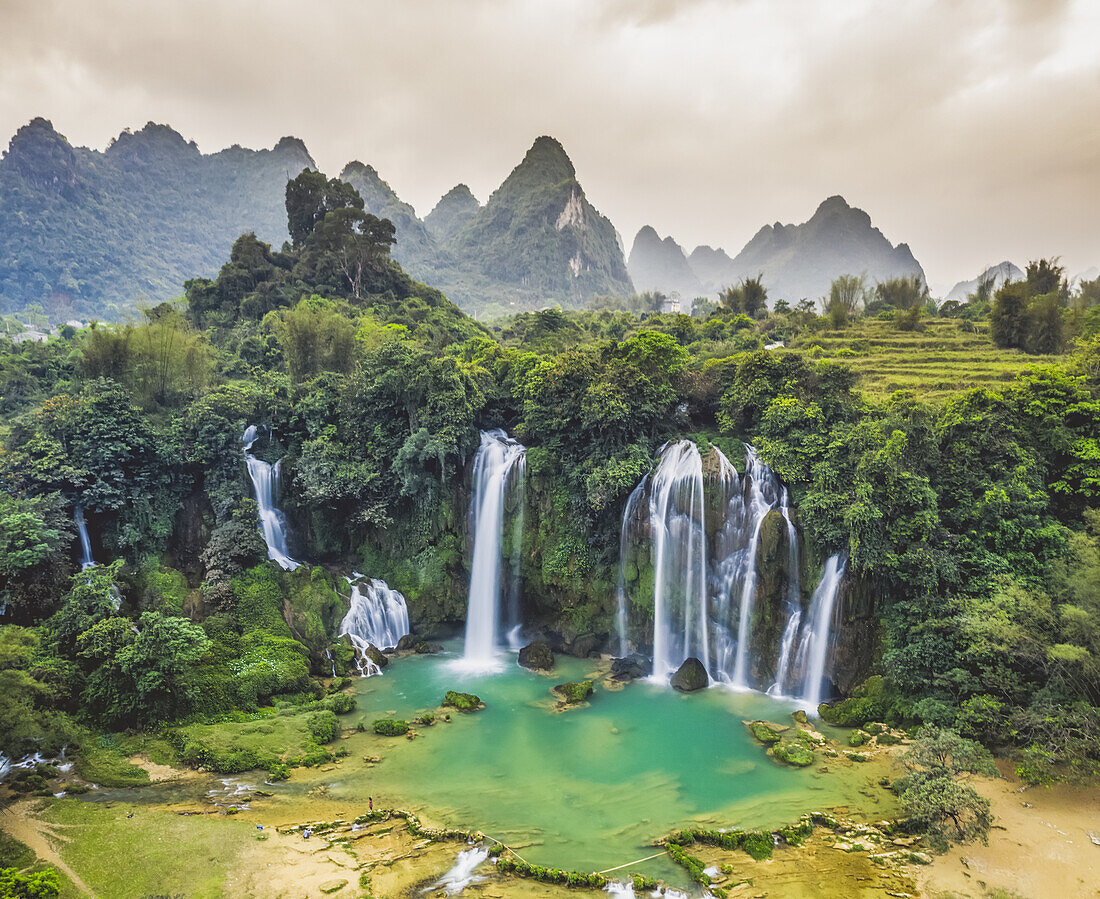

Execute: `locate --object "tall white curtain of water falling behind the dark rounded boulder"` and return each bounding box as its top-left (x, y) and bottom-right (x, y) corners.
top-left (649, 440), bottom-right (711, 678)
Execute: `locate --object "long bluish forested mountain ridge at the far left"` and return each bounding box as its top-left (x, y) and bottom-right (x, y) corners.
top-left (0, 119), bottom-right (314, 320)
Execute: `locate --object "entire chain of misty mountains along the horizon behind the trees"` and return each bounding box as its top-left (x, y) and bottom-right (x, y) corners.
top-left (0, 119), bottom-right (950, 320)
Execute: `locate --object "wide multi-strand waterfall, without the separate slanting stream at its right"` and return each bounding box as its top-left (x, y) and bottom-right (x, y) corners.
top-left (616, 440), bottom-right (800, 688)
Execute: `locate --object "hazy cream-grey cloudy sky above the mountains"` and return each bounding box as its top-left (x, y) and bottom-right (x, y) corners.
top-left (0, 0), bottom-right (1100, 290)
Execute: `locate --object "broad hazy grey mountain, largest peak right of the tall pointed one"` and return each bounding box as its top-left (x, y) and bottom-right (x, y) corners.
top-left (732, 197), bottom-right (924, 303)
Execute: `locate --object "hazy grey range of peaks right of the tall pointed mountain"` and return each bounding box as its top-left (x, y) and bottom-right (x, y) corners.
top-left (630, 197), bottom-right (924, 303)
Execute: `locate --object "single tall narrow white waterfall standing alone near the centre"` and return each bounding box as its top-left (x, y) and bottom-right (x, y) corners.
top-left (464, 430), bottom-right (527, 666)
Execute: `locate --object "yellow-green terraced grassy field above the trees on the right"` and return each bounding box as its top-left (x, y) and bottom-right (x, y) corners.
top-left (791, 318), bottom-right (1065, 401)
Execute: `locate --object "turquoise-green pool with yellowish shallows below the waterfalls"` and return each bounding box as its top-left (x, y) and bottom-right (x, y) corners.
top-left (281, 651), bottom-right (881, 871)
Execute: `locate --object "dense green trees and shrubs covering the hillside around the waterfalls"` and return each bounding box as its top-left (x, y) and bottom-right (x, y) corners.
top-left (0, 166), bottom-right (1100, 814)
